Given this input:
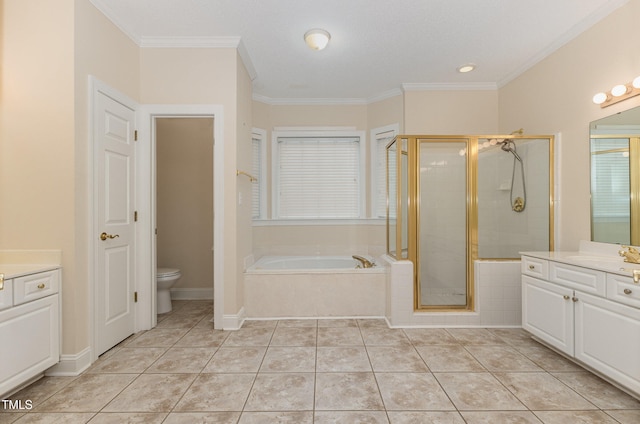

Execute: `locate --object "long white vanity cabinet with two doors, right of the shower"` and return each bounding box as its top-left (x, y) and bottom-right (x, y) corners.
top-left (522, 256), bottom-right (640, 396)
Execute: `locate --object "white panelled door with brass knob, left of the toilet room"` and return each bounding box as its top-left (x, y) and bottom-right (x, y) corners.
top-left (92, 91), bottom-right (135, 356)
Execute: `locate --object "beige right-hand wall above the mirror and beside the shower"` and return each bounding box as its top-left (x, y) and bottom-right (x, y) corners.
top-left (499, 0), bottom-right (640, 250)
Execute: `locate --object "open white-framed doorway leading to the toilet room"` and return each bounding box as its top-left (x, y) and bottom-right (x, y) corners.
top-left (137, 105), bottom-right (224, 328)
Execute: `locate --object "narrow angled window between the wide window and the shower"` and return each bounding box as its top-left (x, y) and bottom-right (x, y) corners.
top-left (371, 124), bottom-right (399, 218)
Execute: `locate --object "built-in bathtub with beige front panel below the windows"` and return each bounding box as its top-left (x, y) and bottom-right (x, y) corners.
top-left (244, 256), bottom-right (387, 318)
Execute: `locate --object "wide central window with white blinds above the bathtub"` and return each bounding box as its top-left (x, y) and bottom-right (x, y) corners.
top-left (272, 130), bottom-right (365, 219)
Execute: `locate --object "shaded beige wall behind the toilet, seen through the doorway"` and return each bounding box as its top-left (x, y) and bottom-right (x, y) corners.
top-left (156, 118), bottom-right (213, 289)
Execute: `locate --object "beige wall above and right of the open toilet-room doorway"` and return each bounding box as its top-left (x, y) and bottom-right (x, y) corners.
top-left (140, 48), bottom-right (250, 314)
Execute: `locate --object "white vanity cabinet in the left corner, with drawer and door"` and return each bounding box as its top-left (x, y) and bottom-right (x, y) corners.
top-left (0, 269), bottom-right (60, 397)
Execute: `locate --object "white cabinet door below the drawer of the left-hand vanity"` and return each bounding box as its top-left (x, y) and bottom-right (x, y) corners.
top-left (0, 294), bottom-right (60, 396)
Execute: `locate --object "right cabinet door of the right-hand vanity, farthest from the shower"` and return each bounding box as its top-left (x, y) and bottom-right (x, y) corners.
top-left (575, 292), bottom-right (640, 393)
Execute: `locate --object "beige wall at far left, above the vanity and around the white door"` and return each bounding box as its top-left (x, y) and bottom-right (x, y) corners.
top-left (0, 0), bottom-right (138, 354)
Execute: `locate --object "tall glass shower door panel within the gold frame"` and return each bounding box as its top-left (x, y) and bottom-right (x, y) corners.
top-left (415, 138), bottom-right (475, 309)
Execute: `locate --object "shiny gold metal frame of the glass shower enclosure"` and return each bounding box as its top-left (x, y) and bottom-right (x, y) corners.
top-left (387, 135), bottom-right (554, 312)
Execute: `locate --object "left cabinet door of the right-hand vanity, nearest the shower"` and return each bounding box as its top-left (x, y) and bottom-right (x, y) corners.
top-left (522, 275), bottom-right (573, 355)
